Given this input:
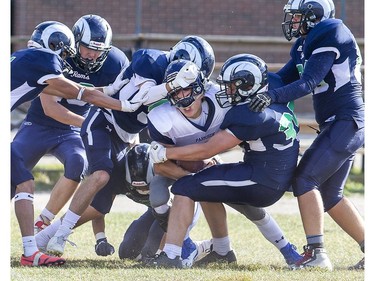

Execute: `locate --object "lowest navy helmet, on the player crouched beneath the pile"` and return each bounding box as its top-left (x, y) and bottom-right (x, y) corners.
top-left (125, 143), bottom-right (154, 195)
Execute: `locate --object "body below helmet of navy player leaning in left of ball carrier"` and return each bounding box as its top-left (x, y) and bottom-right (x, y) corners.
top-left (43, 34), bottom-right (214, 256)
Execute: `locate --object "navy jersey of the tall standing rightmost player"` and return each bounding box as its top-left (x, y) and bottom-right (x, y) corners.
top-left (276, 19), bottom-right (364, 127)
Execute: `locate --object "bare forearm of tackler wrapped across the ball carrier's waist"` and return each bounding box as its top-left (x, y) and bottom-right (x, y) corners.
top-left (166, 130), bottom-right (242, 161)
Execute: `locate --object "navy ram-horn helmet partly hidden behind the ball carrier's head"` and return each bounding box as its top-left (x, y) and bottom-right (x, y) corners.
top-left (170, 35), bottom-right (215, 79)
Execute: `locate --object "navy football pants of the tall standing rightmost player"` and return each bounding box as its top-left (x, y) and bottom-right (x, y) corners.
top-left (293, 120), bottom-right (364, 211)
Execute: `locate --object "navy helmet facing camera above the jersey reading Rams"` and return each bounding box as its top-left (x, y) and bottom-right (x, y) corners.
top-left (72, 15), bottom-right (112, 73)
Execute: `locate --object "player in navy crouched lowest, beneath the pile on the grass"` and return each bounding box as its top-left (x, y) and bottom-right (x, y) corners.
top-left (35, 143), bottom-right (211, 260)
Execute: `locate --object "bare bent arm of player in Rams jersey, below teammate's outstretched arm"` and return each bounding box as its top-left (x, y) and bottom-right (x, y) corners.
top-left (40, 93), bottom-right (85, 127)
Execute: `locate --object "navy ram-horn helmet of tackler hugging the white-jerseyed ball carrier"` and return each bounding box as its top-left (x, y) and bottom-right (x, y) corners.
top-left (216, 54), bottom-right (268, 108)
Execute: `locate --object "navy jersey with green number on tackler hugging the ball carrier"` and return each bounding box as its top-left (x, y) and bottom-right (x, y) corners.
top-left (220, 101), bottom-right (299, 188)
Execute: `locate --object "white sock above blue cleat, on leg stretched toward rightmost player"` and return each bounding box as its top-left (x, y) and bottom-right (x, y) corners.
top-left (253, 213), bottom-right (289, 250)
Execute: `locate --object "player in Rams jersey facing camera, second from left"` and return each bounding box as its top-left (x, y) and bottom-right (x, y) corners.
top-left (12, 15), bottom-right (129, 232)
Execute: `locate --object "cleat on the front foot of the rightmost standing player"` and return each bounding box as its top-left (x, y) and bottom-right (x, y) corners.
top-left (289, 245), bottom-right (333, 271)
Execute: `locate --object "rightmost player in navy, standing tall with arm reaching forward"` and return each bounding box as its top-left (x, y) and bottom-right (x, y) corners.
top-left (250, 0), bottom-right (364, 270)
